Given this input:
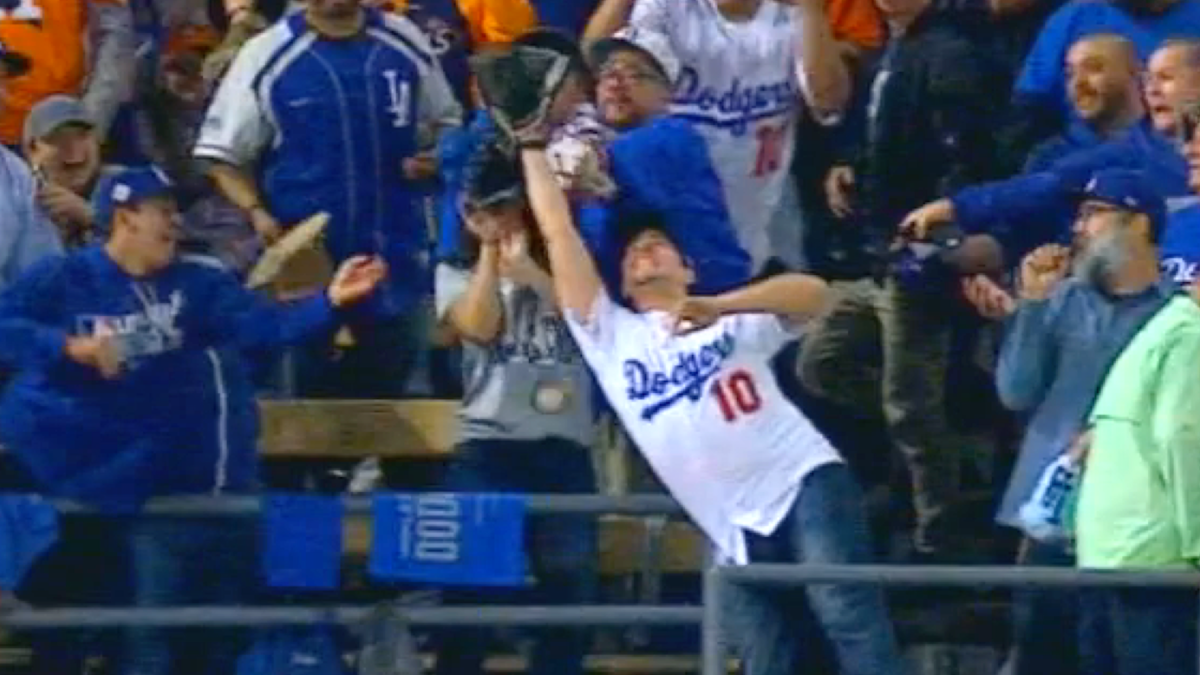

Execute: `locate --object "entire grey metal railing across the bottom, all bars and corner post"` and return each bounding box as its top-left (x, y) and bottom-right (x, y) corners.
top-left (7, 487), bottom-right (1200, 675)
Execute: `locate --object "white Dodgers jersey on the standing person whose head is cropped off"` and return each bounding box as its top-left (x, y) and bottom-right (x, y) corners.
top-left (630, 0), bottom-right (800, 264)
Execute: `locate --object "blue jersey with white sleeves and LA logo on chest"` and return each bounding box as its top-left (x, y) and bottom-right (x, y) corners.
top-left (194, 11), bottom-right (461, 313)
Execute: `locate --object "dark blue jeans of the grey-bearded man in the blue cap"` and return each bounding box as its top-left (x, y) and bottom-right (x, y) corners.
top-left (1012, 539), bottom-right (1075, 675)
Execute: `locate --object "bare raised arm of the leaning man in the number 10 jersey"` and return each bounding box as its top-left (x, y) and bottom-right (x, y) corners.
top-left (521, 148), bottom-right (604, 317)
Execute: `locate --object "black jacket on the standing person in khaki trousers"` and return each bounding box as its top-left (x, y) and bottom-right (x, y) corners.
top-left (838, 12), bottom-right (1008, 238)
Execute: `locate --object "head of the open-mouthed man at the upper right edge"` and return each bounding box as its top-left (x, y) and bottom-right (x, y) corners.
top-left (1145, 40), bottom-right (1200, 136)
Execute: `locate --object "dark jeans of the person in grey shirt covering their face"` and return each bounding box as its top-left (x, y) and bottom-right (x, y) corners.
top-left (437, 438), bottom-right (596, 675)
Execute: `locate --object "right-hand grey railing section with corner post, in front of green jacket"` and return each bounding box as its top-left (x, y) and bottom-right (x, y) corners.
top-left (701, 565), bottom-right (1200, 675)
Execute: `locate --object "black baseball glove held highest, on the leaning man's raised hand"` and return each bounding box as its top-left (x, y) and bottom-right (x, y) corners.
top-left (472, 46), bottom-right (571, 148)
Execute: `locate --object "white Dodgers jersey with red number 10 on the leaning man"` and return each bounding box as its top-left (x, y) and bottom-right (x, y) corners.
top-left (566, 292), bottom-right (841, 565)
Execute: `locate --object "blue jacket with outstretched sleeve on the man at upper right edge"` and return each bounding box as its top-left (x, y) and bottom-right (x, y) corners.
top-left (950, 125), bottom-right (1189, 263)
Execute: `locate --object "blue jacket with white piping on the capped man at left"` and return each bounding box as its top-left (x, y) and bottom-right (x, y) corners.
top-left (0, 246), bottom-right (334, 513)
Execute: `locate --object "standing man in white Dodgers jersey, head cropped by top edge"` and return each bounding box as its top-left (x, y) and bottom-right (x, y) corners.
top-left (626, 0), bottom-right (851, 265)
